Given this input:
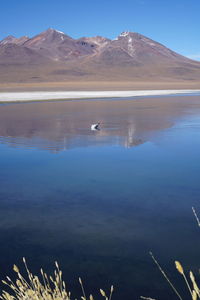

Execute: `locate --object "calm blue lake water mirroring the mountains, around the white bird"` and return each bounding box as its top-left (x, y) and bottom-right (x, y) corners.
top-left (0, 96), bottom-right (200, 300)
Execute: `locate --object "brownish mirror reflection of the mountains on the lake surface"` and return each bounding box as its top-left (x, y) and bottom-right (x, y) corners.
top-left (0, 96), bottom-right (199, 153)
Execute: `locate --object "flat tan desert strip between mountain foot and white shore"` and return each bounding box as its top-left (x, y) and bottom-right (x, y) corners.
top-left (0, 80), bottom-right (200, 92)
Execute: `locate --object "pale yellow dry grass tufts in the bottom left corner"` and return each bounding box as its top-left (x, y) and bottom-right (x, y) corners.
top-left (0, 258), bottom-right (113, 300)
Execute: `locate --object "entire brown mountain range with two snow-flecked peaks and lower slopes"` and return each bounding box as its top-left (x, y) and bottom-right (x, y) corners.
top-left (0, 28), bottom-right (200, 82)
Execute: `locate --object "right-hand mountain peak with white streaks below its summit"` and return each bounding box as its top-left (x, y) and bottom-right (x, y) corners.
top-left (91, 32), bottom-right (190, 65)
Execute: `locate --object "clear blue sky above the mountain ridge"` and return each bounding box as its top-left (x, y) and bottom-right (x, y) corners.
top-left (0, 0), bottom-right (200, 60)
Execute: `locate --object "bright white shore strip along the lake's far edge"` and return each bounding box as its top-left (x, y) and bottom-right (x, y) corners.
top-left (0, 89), bottom-right (200, 102)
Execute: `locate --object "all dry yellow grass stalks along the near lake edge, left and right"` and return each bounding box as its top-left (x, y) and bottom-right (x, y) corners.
top-left (0, 208), bottom-right (200, 300)
